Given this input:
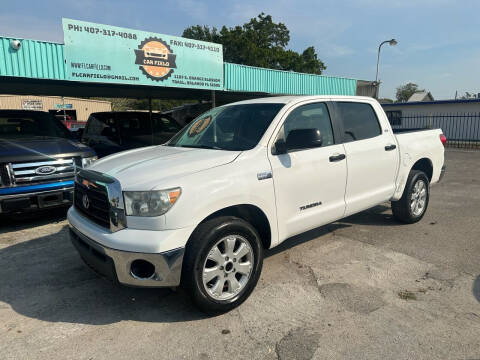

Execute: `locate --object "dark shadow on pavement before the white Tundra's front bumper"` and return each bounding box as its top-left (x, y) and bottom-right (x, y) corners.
top-left (0, 226), bottom-right (206, 325)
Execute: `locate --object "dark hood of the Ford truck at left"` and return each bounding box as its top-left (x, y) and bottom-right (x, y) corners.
top-left (0, 138), bottom-right (95, 163)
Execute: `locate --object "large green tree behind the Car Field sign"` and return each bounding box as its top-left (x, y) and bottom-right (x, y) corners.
top-left (182, 13), bottom-right (326, 75)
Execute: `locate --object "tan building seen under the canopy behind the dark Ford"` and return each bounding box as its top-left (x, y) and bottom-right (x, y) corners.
top-left (0, 95), bottom-right (112, 121)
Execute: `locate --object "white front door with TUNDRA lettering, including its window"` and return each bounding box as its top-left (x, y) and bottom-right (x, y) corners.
top-left (269, 103), bottom-right (347, 241)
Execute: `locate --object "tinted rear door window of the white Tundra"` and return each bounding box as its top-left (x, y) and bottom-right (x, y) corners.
top-left (337, 102), bottom-right (381, 142)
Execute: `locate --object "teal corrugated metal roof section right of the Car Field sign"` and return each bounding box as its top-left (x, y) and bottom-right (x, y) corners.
top-left (224, 63), bottom-right (357, 95)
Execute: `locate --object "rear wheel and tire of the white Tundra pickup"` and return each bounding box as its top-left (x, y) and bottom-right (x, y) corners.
top-left (392, 170), bottom-right (430, 224)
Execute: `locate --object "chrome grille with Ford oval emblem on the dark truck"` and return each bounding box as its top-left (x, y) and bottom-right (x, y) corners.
top-left (9, 158), bottom-right (75, 186)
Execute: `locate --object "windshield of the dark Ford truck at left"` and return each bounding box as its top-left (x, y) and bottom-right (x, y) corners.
top-left (0, 111), bottom-right (71, 139)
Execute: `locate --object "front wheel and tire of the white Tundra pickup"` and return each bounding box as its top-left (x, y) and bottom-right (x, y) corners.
top-left (182, 216), bottom-right (263, 315)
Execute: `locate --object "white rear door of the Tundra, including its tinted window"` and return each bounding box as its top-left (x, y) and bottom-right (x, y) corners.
top-left (335, 101), bottom-right (398, 216)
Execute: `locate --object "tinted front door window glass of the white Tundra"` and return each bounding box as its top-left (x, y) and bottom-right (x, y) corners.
top-left (280, 103), bottom-right (334, 146)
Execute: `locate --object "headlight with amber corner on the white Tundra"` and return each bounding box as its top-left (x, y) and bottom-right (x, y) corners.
top-left (123, 188), bottom-right (181, 216)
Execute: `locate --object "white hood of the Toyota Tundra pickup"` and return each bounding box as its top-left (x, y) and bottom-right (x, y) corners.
top-left (89, 146), bottom-right (241, 191)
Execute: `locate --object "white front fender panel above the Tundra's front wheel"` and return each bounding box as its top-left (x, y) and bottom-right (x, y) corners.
top-left (161, 147), bottom-right (277, 246)
